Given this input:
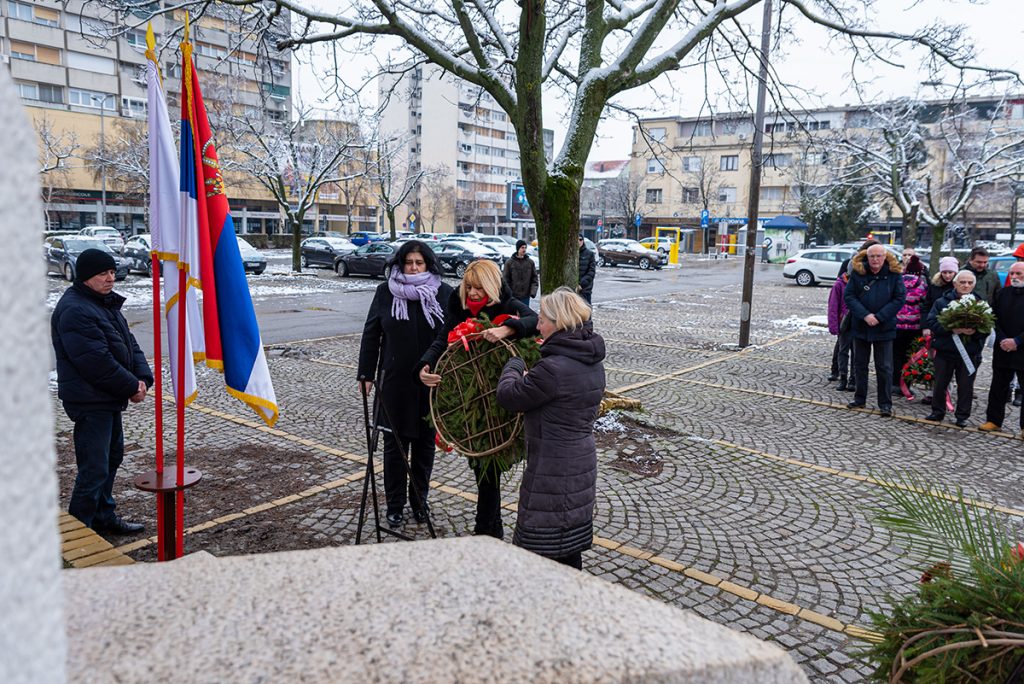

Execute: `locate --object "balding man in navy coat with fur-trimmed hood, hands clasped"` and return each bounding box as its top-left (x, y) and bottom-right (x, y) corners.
top-left (843, 245), bottom-right (906, 418)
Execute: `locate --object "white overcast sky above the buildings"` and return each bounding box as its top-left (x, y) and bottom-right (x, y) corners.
top-left (296, 0), bottom-right (1024, 160)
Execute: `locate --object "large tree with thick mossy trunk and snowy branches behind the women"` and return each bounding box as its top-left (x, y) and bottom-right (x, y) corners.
top-left (96, 0), bottom-right (1016, 292)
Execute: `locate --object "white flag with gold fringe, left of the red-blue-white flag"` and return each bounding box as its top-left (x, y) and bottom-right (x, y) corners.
top-left (145, 26), bottom-right (204, 405)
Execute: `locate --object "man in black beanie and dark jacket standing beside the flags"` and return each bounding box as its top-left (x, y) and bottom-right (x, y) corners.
top-left (50, 249), bottom-right (153, 535)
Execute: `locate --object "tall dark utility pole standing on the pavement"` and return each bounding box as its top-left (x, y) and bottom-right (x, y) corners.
top-left (739, 0), bottom-right (772, 348)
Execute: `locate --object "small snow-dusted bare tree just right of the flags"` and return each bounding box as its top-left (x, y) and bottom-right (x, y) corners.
top-left (222, 111), bottom-right (365, 271)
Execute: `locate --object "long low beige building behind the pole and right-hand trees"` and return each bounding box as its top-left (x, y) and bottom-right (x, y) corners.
top-left (630, 97), bottom-right (1024, 251)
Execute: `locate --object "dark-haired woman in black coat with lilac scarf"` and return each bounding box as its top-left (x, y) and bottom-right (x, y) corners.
top-left (358, 240), bottom-right (453, 527)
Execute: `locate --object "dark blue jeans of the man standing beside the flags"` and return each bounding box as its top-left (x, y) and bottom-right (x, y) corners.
top-left (68, 410), bottom-right (125, 527)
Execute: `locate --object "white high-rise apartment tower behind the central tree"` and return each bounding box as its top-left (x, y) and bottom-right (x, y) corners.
top-left (380, 65), bottom-right (554, 234)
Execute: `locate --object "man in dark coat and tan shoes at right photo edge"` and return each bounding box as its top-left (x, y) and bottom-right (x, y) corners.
top-left (978, 261), bottom-right (1024, 437)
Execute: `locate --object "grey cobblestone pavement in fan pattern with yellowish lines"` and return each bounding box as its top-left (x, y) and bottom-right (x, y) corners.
top-left (56, 264), bottom-right (1024, 682)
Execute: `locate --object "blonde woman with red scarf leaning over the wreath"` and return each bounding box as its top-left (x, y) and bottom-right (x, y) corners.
top-left (420, 259), bottom-right (537, 539)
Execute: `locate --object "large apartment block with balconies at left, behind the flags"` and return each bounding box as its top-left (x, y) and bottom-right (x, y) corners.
top-left (0, 0), bottom-right (292, 232)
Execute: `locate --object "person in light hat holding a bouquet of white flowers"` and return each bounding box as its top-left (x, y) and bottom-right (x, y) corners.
top-left (925, 269), bottom-right (987, 427)
